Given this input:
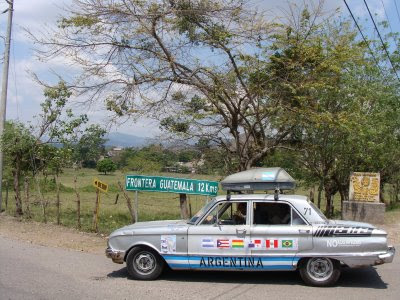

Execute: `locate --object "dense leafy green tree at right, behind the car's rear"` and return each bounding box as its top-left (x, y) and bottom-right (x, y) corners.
top-left (264, 10), bottom-right (400, 215)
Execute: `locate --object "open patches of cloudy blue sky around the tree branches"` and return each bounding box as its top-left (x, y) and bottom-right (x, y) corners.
top-left (0, 0), bottom-right (400, 137)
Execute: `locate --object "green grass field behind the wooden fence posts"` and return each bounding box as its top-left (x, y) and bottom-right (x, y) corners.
top-left (3, 169), bottom-right (398, 234)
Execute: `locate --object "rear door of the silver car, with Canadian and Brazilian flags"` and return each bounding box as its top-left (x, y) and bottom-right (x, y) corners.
top-left (250, 200), bottom-right (313, 270)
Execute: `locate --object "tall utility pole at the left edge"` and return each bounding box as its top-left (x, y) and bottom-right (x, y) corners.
top-left (0, 0), bottom-right (14, 212)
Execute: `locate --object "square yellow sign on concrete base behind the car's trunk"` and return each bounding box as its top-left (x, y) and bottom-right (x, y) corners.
top-left (349, 172), bottom-right (381, 202)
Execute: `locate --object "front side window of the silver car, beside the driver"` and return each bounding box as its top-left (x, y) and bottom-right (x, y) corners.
top-left (200, 201), bottom-right (247, 225)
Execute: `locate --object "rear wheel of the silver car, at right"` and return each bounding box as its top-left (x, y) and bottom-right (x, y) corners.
top-left (300, 257), bottom-right (340, 287)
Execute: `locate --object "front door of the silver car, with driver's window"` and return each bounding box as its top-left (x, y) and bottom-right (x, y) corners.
top-left (188, 201), bottom-right (251, 269)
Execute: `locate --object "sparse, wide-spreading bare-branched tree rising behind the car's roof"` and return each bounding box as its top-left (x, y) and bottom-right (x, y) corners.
top-left (32, 0), bottom-right (296, 170)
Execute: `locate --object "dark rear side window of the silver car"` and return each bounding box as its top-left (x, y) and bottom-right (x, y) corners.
top-left (253, 202), bottom-right (292, 225)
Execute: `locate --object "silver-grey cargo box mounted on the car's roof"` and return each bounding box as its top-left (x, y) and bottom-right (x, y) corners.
top-left (221, 168), bottom-right (296, 200)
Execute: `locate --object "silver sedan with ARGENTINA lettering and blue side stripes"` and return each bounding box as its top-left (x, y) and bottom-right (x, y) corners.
top-left (106, 169), bottom-right (395, 286)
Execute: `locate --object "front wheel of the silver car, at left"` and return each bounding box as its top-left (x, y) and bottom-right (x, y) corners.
top-left (126, 247), bottom-right (165, 280)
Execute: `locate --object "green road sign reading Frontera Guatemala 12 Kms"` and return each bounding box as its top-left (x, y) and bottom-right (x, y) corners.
top-left (125, 175), bottom-right (218, 196)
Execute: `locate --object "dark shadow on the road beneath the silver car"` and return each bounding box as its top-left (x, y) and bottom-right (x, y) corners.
top-left (107, 267), bottom-right (387, 289)
